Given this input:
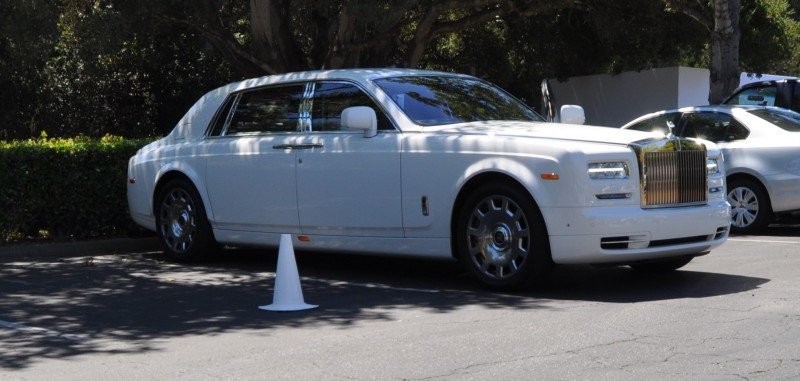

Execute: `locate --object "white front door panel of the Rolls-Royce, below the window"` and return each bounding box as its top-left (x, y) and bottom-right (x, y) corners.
top-left (297, 132), bottom-right (403, 237)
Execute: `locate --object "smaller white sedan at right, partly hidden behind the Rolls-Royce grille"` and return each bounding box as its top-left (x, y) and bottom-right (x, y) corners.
top-left (622, 106), bottom-right (800, 234)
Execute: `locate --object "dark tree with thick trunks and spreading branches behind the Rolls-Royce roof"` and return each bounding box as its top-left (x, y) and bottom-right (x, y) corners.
top-left (161, 0), bottom-right (575, 76)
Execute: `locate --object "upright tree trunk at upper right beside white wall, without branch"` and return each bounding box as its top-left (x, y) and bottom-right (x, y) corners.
top-left (708, 0), bottom-right (742, 104)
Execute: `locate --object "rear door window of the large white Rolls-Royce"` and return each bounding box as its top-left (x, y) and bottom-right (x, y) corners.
top-left (225, 85), bottom-right (305, 135)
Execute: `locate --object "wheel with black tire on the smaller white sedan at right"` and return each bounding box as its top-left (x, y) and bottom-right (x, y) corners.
top-left (728, 178), bottom-right (772, 234)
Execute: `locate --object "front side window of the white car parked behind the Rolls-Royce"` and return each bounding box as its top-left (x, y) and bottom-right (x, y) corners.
top-left (681, 112), bottom-right (749, 142)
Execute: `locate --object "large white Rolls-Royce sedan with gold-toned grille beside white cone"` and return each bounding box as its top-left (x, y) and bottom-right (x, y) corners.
top-left (128, 69), bottom-right (730, 288)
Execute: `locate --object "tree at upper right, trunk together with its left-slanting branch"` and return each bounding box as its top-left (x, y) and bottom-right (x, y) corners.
top-left (664, 0), bottom-right (742, 104)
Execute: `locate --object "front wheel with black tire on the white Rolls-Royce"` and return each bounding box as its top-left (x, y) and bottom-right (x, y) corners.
top-left (455, 184), bottom-right (553, 290)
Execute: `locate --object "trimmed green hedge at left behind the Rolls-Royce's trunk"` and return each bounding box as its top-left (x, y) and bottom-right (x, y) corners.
top-left (0, 136), bottom-right (152, 244)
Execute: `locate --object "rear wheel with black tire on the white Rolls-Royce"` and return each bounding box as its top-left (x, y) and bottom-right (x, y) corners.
top-left (155, 178), bottom-right (218, 262)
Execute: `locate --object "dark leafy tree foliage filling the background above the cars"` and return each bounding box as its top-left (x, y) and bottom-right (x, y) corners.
top-left (0, 0), bottom-right (800, 140)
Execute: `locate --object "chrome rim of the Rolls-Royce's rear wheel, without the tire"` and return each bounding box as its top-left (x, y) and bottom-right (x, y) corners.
top-left (159, 188), bottom-right (197, 253)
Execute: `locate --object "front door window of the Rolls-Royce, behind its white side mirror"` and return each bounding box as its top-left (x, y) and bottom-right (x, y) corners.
top-left (311, 82), bottom-right (394, 131)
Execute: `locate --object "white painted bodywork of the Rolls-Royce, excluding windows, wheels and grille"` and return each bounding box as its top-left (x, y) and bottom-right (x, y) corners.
top-left (128, 69), bottom-right (730, 263)
